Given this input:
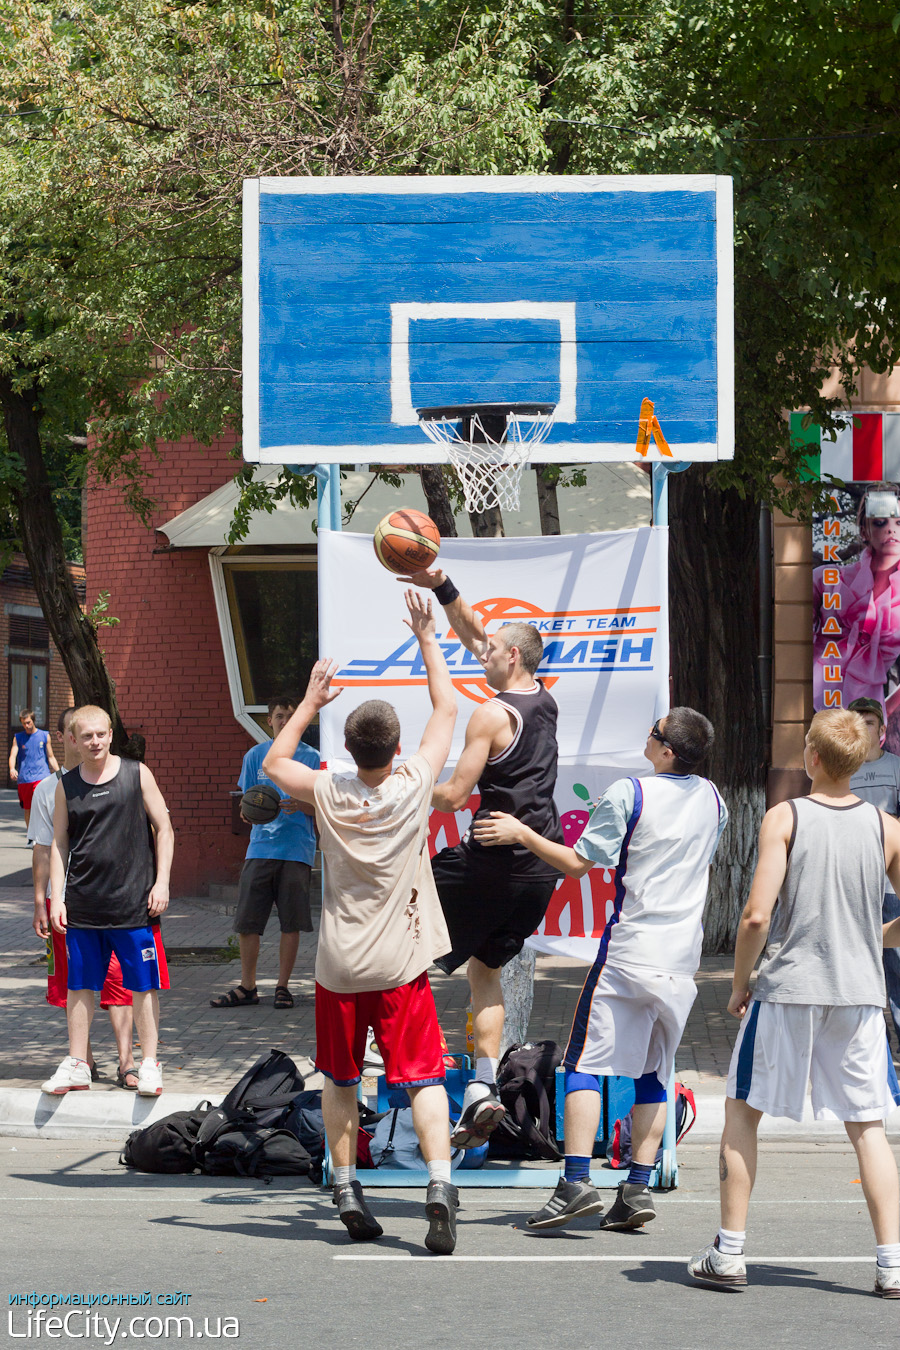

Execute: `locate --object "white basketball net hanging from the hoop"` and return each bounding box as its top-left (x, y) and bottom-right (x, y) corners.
top-left (421, 412), bottom-right (553, 512)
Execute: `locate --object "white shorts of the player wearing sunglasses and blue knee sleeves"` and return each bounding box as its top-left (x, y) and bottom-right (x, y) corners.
top-left (564, 965), bottom-right (696, 1087)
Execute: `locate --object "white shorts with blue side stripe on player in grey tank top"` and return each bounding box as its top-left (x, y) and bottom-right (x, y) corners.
top-left (726, 1002), bottom-right (900, 1121)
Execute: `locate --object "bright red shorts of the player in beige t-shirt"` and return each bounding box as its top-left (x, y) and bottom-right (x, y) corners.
top-left (316, 971), bottom-right (444, 1088)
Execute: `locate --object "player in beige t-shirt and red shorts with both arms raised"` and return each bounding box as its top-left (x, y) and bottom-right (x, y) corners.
top-left (263, 590), bottom-right (457, 1254)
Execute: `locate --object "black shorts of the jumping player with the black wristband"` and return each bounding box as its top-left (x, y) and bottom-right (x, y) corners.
top-left (432, 848), bottom-right (557, 975)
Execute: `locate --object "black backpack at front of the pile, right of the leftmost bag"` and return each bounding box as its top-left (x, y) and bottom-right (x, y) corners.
top-left (193, 1103), bottom-right (312, 1181)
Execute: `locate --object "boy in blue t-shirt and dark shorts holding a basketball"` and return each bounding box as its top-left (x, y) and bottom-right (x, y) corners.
top-left (209, 694), bottom-right (320, 1008)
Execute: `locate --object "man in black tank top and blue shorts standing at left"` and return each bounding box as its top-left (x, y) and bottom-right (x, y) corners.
top-left (40, 705), bottom-right (175, 1096)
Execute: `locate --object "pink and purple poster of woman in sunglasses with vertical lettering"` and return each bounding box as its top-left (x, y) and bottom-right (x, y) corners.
top-left (812, 481), bottom-right (900, 753)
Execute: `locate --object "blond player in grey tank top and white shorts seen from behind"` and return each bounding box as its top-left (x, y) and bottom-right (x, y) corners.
top-left (688, 709), bottom-right (900, 1299)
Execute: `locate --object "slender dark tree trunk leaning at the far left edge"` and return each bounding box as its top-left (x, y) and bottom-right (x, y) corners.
top-left (0, 375), bottom-right (135, 753)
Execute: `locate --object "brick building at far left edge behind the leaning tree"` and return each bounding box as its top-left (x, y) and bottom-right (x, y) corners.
top-left (0, 554), bottom-right (79, 787)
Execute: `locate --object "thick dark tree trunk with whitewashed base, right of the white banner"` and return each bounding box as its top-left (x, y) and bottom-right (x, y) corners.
top-left (669, 464), bottom-right (765, 954)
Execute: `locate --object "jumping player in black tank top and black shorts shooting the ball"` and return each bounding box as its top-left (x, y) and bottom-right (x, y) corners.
top-left (401, 567), bottom-right (563, 1149)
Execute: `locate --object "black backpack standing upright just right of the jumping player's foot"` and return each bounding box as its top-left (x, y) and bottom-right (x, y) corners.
top-left (487, 1041), bottom-right (563, 1162)
